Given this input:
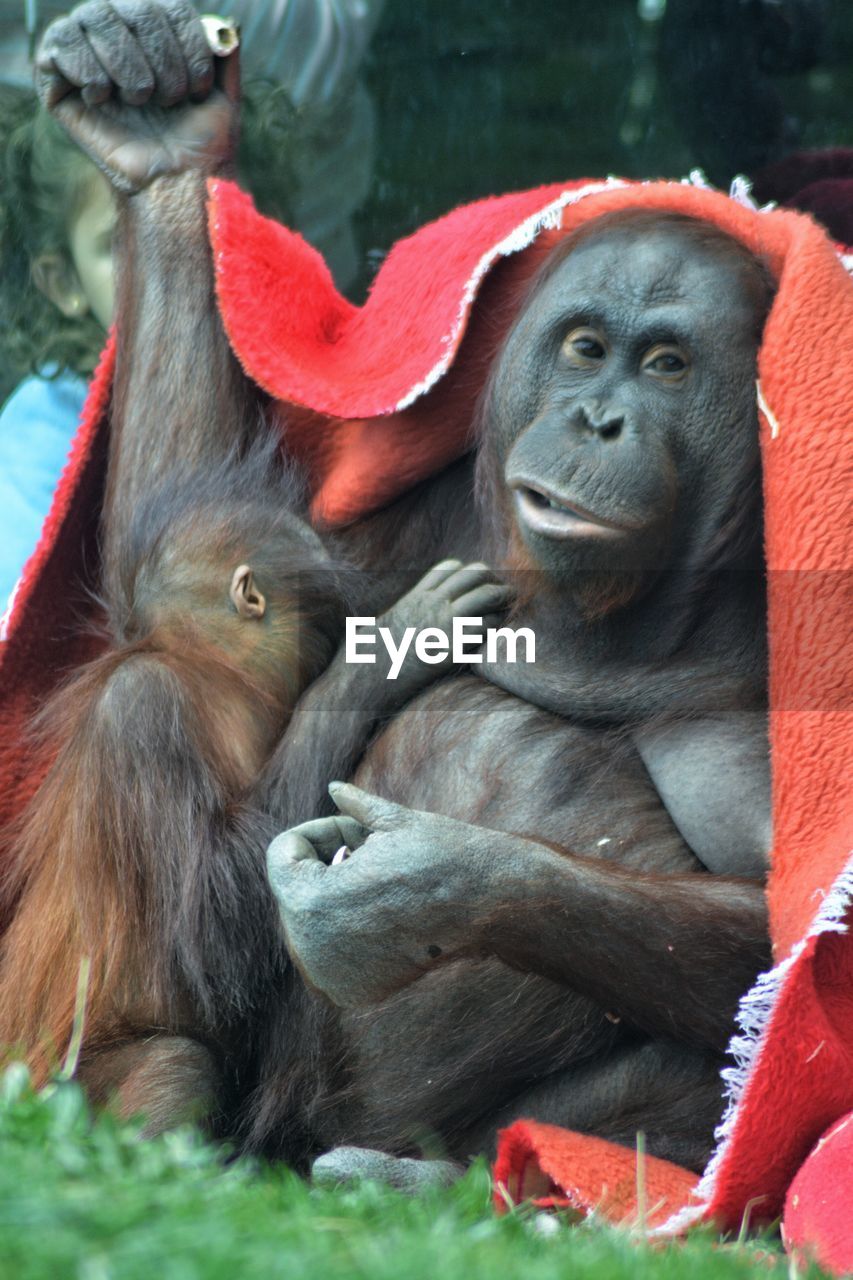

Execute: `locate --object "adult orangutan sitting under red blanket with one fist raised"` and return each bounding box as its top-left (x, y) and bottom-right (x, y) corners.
top-left (8, 0), bottom-right (770, 1165)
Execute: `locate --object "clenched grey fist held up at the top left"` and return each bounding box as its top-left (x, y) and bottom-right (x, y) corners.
top-left (36, 0), bottom-right (240, 195)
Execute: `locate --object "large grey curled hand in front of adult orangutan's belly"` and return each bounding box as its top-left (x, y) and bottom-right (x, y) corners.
top-left (266, 783), bottom-right (507, 1007)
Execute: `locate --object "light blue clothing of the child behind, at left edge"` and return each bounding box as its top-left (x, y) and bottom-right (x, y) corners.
top-left (0, 372), bottom-right (88, 612)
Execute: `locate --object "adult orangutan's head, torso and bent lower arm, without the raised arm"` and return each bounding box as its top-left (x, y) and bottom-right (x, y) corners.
top-left (268, 220), bottom-right (770, 1166)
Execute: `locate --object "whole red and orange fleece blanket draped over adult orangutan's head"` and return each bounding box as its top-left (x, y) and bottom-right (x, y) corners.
top-left (0, 179), bottom-right (853, 1270)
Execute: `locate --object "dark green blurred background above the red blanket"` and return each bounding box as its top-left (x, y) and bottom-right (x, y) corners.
top-left (0, 0), bottom-right (853, 280)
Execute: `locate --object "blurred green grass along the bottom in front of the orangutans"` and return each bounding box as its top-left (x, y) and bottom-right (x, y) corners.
top-left (0, 1068), bottom-right (817, 1280)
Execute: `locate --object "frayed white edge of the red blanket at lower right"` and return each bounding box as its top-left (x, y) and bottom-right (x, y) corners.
top-left (649, 851), bottom-right (853, 1235)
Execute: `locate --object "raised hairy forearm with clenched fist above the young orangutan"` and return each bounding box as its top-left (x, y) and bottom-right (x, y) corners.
top-left (36, 0), bottom-right (257, 567)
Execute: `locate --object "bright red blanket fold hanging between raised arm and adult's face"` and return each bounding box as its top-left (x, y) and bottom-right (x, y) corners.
top-left (209, 182), bottom-right (602, 525)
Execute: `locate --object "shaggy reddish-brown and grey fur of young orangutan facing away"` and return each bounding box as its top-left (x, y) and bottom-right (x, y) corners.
top-left (0, 437), bottom-right (348, 1107)
